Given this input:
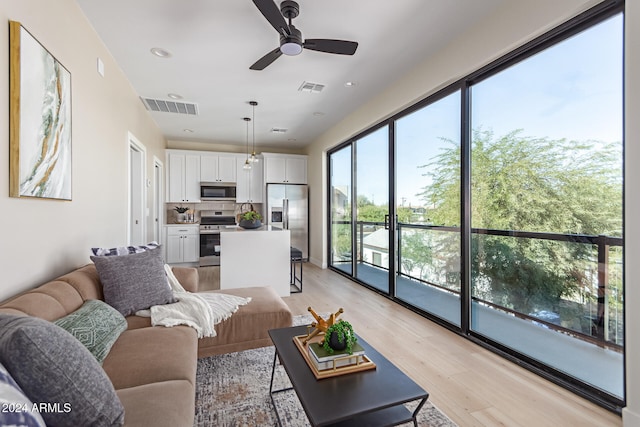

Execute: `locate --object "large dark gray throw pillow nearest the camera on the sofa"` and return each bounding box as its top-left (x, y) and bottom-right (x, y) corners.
top-left (0, 314), bottom-right (124, 427)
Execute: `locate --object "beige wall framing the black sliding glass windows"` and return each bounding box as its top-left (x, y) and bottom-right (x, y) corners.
top-left (307, 0), bottom-right (640, 427)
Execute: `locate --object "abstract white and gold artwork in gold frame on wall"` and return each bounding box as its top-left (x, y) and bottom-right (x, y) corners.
top-left (9, 21), bottom-right (71, 200)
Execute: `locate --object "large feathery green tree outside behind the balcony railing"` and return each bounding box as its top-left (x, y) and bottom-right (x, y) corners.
top-left (418, 130), bottom-right (622, 313)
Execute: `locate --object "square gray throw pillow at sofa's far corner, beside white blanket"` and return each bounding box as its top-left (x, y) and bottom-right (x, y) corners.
top-left (91, 248), bottom-right (175, 316)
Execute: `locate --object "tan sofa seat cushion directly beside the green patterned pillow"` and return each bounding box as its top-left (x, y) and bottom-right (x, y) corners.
top-left (102, 326), bottom-right (198, 390)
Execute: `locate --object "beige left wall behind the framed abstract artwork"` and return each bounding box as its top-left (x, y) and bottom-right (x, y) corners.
top-left (0, 0), bottom-right (165, 300)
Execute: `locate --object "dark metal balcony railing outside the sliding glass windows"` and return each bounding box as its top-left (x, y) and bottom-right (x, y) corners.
top-left (332, 221), bottom-right (623, 351)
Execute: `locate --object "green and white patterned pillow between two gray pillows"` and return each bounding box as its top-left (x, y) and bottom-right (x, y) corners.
top-left (54, 300), bottom-right (127, 364)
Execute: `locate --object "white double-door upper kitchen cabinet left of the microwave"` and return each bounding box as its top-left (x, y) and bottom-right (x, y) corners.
top-left (166, 151), bottom-right (200, 203)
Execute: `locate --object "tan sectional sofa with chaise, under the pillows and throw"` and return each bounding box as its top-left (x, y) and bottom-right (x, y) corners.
top-left (0, 264), bottom-right (292, 426)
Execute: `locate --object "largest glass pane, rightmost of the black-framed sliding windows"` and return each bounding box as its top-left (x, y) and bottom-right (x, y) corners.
top-left (471, 16), bottom-right (624, 398)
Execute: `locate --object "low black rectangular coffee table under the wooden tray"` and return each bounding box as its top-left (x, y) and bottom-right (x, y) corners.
top-left (269, 326), bottom-right (429, 427)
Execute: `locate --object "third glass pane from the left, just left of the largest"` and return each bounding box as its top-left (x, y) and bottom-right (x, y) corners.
top-left (396, 92), bottom-right (461, 326)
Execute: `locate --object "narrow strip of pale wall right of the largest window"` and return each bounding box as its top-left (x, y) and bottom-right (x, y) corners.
top-left (622, 0), bottom-right (640, 427)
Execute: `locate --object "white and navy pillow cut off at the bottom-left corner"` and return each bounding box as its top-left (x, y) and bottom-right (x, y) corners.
top-left (0, 364), bottom-right (46, 427)
